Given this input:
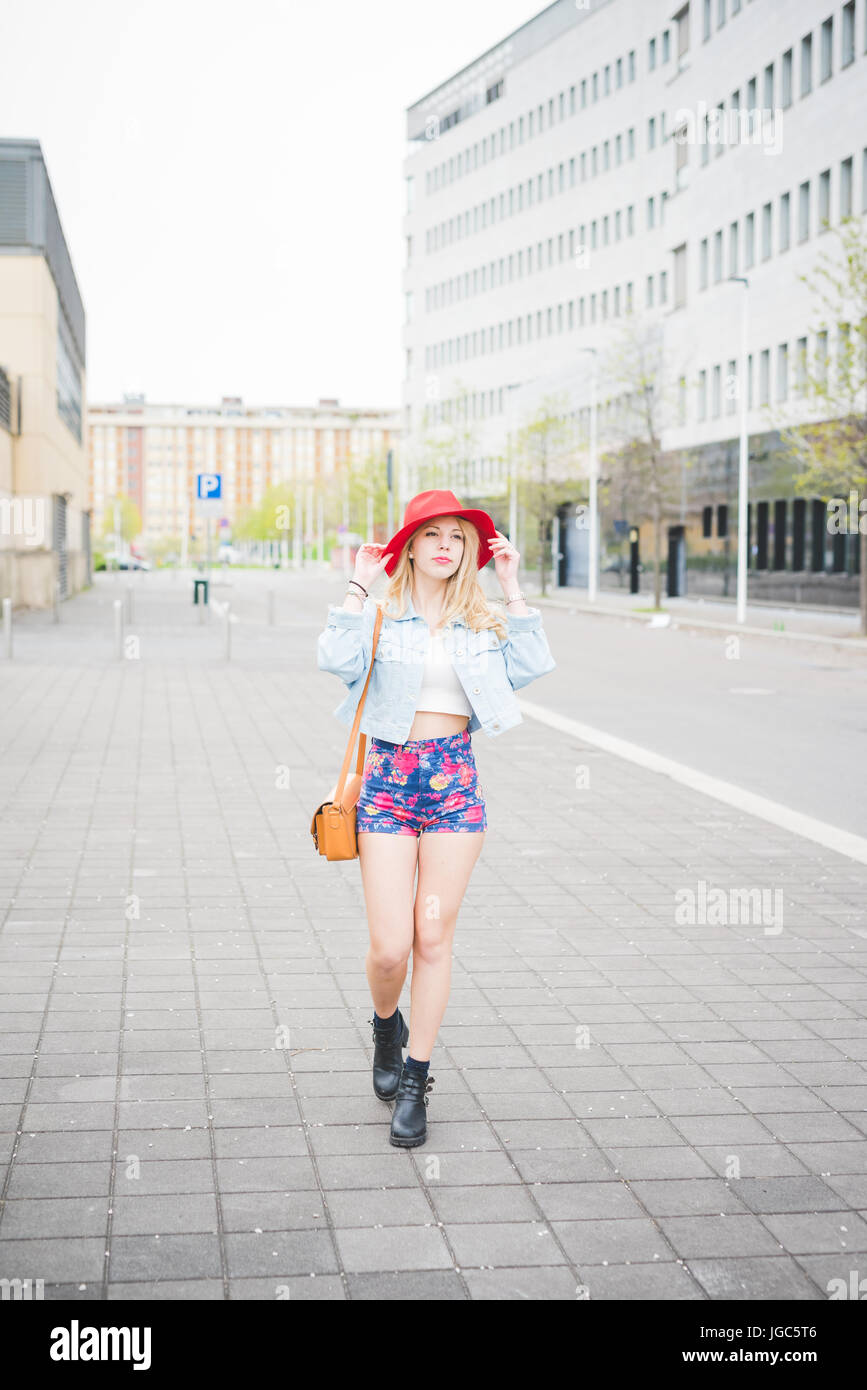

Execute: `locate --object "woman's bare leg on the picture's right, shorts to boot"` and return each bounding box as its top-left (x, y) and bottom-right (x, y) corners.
top-left (410, 830), bottom-right (485, 1062)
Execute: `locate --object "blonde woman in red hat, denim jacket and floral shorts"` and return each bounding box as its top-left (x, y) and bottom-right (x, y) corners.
top-left (317, 491), bottom-right (556, 1148)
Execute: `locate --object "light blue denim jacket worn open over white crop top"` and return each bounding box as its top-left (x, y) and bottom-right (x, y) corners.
top-left (317, 598), bottom-right (557, 744)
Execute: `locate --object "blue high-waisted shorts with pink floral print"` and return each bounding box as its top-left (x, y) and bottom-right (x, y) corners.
top-left (356, 728), bottom-right (488, 835)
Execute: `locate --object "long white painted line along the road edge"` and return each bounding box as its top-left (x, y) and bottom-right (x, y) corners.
top-left (518, 698), bottom-right (867, 865)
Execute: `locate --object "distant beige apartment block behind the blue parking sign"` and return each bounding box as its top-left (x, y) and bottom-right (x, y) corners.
top-left (88, 395), bottom-right (399, 549)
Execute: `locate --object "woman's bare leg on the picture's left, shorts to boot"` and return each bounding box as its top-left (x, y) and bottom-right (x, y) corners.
top-left (358, 830), bottom-right (418, 1019)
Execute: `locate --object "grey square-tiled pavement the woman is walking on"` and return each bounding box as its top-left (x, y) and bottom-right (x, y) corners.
top-left (0, 574), bottom-right (867, 1301)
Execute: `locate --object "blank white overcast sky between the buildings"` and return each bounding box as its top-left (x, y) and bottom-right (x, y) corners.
top-left (0, 0), bottom-right (546, 406)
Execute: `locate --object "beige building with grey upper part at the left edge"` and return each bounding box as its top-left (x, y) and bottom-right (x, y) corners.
top-left (0, 140), bottom-right (90, 607)
